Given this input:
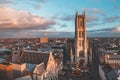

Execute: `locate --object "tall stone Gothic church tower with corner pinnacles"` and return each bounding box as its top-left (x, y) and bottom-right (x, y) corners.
top-left (75, 11), bottom-right (88, 65)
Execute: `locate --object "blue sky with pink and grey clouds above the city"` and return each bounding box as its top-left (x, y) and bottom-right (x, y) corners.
top-left (0, 0), bottom-right (120, 38)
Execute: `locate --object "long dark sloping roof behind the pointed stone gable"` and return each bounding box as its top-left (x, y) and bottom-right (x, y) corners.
top-left (19, 51), bottom-right (49, 68)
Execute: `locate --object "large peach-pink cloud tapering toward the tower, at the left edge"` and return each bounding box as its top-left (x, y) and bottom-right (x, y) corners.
top-left (0, 7), bottom-right (56, 30)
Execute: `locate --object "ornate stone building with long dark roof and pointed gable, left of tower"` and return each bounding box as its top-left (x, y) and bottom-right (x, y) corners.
top-left (13, 51), bottom-right (63, 80)
